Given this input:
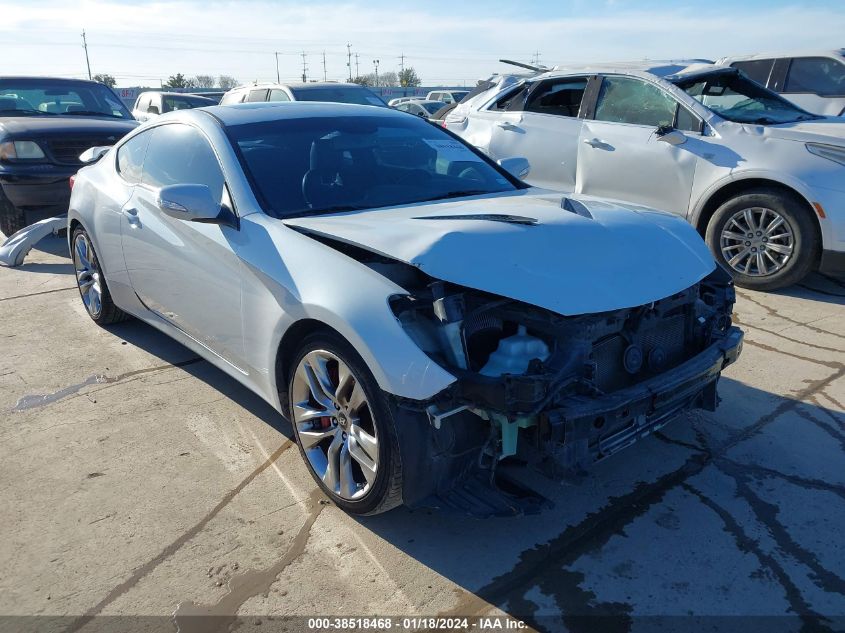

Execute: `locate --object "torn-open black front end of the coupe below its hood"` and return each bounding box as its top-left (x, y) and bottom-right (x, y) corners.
top-left (386, 262), bottom-right (742, 505)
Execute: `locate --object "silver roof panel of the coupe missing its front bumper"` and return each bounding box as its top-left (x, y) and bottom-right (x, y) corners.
top-left (199, 101), bottom-right (407, 126)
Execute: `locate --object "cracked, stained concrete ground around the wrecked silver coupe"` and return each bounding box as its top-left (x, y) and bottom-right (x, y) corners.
top-left (0, 233), bottom-right (845, 632)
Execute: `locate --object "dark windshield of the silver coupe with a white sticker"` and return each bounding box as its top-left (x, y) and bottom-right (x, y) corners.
top-left (227, 116), bottom-right (519, 218)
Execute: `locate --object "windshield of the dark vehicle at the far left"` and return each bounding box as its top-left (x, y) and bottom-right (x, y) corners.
top-left (0, 78), bottom-right (132, 119)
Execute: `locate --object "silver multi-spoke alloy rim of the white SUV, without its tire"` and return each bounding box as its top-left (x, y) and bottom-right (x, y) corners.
top-left (720, 207), bottom-right (795, 277)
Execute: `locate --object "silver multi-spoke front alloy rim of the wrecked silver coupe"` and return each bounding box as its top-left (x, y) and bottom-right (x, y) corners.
top-left (291, 350), bottom-right (379, 500)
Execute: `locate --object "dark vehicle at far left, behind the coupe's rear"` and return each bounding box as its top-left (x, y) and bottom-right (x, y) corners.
top-left (0, 77), bottom-right (138, 237)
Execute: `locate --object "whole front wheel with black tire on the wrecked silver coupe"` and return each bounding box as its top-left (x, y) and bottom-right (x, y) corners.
top-left (287, 330), bottom-right (402, 515)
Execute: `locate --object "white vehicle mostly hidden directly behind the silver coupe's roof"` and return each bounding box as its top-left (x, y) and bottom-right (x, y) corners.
top-left (220, 82), bottom-right (387, 107)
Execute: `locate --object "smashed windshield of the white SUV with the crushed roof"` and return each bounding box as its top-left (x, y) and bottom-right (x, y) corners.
top-left (675, 72), bottom-right (818, 125)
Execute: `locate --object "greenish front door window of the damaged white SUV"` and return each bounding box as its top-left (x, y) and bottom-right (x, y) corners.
top-left (595, 77), bottom-right (677, 127)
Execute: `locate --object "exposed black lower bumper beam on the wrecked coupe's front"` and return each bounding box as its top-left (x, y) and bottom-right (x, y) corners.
top-left (545, 327), bottom-right (743, 469)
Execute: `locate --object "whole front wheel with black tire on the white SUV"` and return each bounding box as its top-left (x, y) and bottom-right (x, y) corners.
top-left (705, 188), bottom-right (821, 291)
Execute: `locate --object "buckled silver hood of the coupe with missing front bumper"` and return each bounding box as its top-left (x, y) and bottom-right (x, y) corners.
top-left (284, 190), bottom-right (715, 315)
